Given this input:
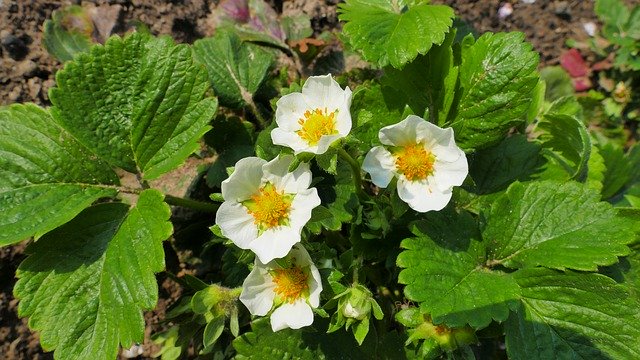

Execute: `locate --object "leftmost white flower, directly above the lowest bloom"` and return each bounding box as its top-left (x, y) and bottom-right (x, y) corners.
top-left (216, 155), bottom-right (320, 263)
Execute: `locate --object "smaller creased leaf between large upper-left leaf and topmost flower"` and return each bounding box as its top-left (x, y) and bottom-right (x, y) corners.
top-left (193, 31), bottom-right (274, 108)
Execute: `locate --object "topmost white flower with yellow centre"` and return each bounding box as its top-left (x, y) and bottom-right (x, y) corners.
top-left (271, 74), bottom-right (351, 154)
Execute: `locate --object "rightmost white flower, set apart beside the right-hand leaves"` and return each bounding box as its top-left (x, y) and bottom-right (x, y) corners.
top-left (362, 115), bottom-right (469, 212)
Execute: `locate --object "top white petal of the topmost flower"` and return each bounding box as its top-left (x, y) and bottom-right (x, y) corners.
top-left (302, 74), bottom-right (351, 112)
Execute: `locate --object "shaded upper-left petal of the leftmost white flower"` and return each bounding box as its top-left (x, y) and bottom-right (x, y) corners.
top-left (222, 157), bottom-right (267, 202)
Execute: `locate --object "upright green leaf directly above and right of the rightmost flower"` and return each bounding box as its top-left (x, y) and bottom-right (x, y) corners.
top-left (450, 33), bottom-right (538, 150)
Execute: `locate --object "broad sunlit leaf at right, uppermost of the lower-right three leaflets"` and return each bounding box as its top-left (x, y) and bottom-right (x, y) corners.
top-left (482, 181), bottom-right (635, 271)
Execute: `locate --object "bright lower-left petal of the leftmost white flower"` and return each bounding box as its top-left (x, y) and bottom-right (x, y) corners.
top-left (216, 201), bottom-right (258, 249)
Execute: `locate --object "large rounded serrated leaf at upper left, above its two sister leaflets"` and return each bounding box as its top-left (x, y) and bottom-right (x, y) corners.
top-left (50, 33), bottom-right (217, 180)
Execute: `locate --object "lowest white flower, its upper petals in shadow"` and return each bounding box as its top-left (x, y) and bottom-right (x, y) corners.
top-left (240, 244), bottom-right (322, 331)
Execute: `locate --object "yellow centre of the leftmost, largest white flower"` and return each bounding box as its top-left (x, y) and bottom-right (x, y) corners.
top-left (243, 183), bottom-right (293, 230)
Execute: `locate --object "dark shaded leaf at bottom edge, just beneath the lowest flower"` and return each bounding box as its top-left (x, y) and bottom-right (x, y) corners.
top-left (233, 317), bottom-right (377, 360)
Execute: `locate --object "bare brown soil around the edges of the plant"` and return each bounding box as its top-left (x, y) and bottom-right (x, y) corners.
top-left (0, 0), bottom-right (595, 360)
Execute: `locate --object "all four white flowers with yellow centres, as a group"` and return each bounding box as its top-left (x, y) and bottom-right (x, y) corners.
top-left (216, 75), bottom-right (468, 331)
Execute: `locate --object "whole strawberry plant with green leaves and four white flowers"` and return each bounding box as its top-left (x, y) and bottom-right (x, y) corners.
top-left (0, 0), bottom-right (640, 359)
